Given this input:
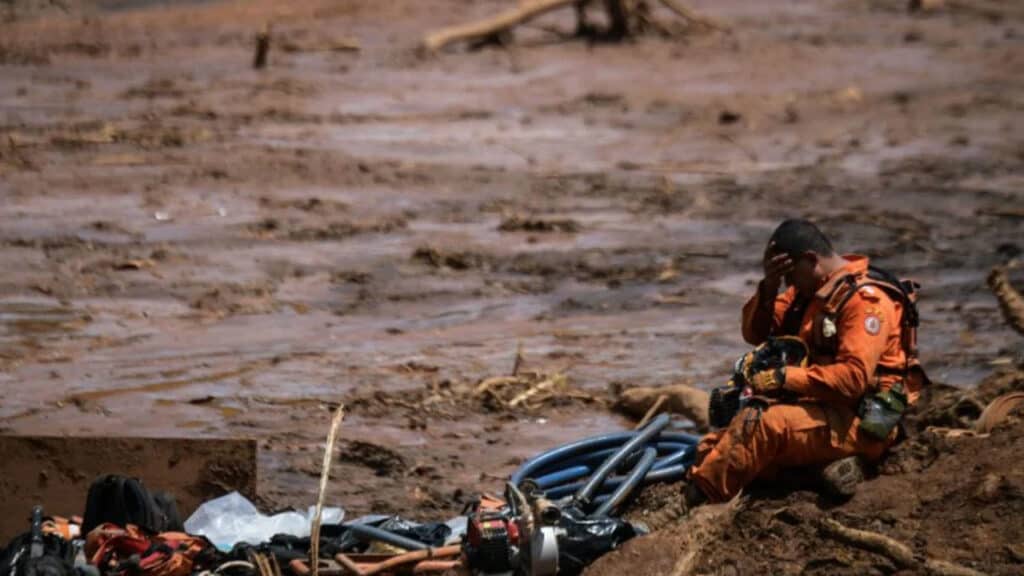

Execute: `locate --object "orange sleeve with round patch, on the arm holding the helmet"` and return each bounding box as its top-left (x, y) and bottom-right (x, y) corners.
top-left (784, 289), bottom-right (896, 406)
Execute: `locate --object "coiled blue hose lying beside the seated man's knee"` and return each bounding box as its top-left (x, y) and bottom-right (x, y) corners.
top-left (510, 414), bottom-right (700, 518)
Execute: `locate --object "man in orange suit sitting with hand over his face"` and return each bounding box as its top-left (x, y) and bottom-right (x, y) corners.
top-left (685, 219), bottom-right (927, 505)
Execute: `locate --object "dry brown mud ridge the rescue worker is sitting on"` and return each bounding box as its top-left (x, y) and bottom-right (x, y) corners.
top-left (585, 370), bottom-right (1024, 576)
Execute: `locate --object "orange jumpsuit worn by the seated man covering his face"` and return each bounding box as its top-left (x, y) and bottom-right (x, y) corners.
top-left (690, 255), bottom-right (916, 502)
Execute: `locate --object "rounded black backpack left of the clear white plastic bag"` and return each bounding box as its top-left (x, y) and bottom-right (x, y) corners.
top-left (80, 475), bottom-right (184, 532)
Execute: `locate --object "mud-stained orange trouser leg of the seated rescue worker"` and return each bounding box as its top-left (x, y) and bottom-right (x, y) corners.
top-left (690, 404), bottom-right (885, 502)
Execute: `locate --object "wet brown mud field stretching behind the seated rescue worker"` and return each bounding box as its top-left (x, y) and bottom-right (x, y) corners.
top-left (0, 0), bottom-right (1024, 574)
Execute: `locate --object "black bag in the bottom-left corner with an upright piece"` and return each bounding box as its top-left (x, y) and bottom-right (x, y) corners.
top-left (0, 506), bottom-right (76, 576)
